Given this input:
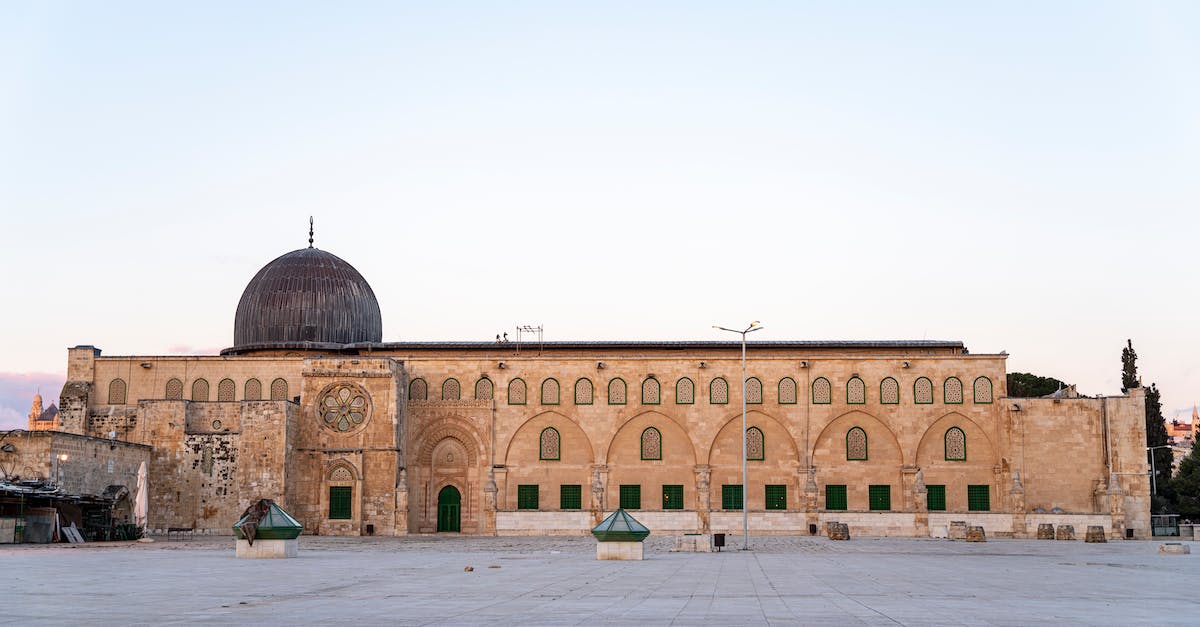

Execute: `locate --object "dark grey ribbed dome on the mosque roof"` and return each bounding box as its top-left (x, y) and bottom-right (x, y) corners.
top-left (233, 247), bottom-right (383, 348)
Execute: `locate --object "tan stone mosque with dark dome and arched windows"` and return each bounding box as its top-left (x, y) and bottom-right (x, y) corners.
top-left (37, 234), bottom-right (1150, 538)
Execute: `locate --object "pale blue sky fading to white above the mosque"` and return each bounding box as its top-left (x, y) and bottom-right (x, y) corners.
top-left (0, 0), bottom-right (1200, 428)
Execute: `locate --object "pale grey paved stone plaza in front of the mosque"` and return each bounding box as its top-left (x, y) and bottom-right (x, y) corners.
top-left (0, 536), bottom-right (1200, 625)
